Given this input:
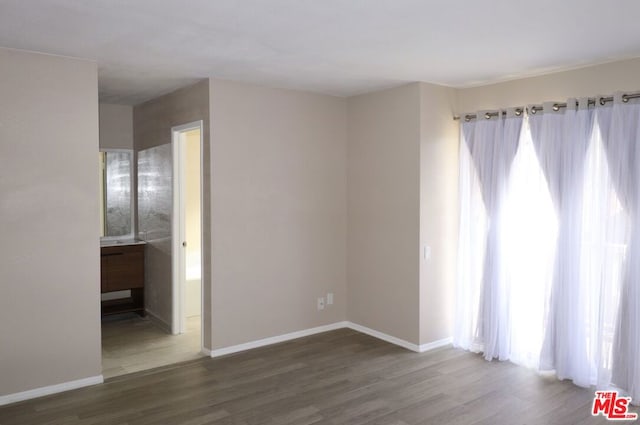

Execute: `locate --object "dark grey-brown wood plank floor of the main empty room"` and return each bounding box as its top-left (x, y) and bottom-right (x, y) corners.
top-left (0, 329), bottom-right (637, 425)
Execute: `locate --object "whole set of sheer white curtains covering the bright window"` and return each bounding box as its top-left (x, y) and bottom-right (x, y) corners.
top-left (454, 95), bottom-right (640, 403)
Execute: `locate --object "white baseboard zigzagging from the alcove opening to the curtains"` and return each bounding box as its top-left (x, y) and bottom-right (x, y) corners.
top-left (210, 321), bottom-right (451, 357)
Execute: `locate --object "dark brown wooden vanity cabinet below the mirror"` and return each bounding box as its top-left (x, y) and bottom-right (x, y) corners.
top-left (100, 244), bottom-right (145, 316)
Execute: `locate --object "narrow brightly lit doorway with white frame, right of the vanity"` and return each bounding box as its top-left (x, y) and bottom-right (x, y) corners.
top-left (171, 121), bottom-right (202, 349)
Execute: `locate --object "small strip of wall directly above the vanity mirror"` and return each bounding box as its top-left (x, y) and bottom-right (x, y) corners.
top-left (99, 103), bottom-right (133, 149)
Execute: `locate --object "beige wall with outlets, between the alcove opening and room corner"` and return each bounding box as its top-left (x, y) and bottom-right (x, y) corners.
top-left (210, 80), bottom-right (346, 348)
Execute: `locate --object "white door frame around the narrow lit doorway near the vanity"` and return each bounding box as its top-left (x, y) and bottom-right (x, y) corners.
top-left (171, 120), bottom-right (204, 350)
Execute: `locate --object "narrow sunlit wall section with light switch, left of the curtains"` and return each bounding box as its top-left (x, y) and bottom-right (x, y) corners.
top-left (420, 83), bottom-right (459, 344)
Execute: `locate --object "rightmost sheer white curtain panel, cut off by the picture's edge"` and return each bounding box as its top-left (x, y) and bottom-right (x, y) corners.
top-left (598, 94), bottom-right (640, 403)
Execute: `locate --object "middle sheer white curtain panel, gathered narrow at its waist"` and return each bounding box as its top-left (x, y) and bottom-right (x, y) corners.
top-left (529, 99), bottom-right (593, 385)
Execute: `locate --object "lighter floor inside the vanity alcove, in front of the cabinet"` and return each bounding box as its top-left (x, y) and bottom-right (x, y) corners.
top-left (102, 314), bottom-right (202, 378)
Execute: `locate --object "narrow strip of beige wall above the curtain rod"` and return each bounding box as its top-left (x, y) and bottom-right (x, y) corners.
top-left (456, 58), bottom-right (640, 114)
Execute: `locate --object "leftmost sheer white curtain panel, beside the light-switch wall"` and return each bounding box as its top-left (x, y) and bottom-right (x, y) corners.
top-left (454, 109), bottom-right (522, 359)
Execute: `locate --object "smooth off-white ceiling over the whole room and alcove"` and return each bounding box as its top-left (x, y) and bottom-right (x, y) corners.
top-left (0, 0), bottom-right (640, 104)
